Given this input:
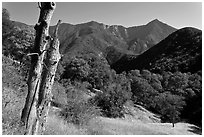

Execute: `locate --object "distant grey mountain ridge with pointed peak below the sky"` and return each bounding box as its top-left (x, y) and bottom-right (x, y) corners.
top-left (47, 19), bottom-right (176, 64)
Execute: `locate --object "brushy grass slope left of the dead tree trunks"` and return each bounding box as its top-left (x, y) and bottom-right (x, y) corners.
top-left (2, 56), bottom-right (27, 135)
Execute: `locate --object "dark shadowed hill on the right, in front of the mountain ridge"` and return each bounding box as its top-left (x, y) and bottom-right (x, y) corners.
top-left (112, 27), bottom-right (202, 73)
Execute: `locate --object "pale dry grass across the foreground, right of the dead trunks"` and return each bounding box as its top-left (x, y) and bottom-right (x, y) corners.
top-left (45, 106), bottom-right (201, 135)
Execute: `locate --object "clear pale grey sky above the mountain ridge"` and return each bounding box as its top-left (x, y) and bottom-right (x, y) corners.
top-left (2, 2), bottom-right (202, 29)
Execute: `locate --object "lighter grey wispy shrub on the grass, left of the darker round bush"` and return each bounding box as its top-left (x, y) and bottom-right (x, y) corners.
top-left (60, 87), bottom-right (100, 125)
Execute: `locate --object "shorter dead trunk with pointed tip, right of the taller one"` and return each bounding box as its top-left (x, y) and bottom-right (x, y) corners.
top-left (36, 20), bottom-right (61, 134)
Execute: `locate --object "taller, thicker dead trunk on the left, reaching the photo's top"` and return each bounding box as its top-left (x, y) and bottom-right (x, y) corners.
top-left (21, 2), bottom-right (56, 134)
